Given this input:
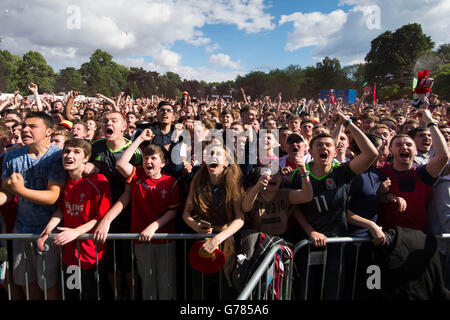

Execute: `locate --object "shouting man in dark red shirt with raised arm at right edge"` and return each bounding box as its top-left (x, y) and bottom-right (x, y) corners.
top-left (379, 109), bottom-right (449, 231)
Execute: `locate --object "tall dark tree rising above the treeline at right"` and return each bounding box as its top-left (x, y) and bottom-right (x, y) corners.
top-left (365, 23), bottom-right (434, 87)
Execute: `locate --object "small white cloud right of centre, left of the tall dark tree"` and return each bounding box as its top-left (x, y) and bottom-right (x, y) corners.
top-left (279, 10), bottom-right (347, 51)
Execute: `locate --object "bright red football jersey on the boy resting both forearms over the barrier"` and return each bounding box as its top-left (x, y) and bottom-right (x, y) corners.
top-left (59, 174), bottom-right (112, 269)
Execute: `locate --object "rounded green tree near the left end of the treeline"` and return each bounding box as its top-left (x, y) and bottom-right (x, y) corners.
top-left (17, 51), bottom-right (55, 94)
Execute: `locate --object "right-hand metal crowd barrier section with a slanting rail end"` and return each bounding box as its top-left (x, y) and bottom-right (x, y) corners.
top-left (237, 234), bottom-right (450, 300)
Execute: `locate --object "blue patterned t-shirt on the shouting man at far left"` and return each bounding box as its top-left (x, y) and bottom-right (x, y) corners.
top-left (2, 144), bottom-right (66, 233)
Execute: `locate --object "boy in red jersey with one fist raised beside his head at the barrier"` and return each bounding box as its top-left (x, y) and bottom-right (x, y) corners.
top-left (94, 129), bottom-right (179, 300)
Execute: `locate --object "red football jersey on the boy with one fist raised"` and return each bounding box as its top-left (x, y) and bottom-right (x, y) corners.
top-left (127, 167), bottom-right (180, 243)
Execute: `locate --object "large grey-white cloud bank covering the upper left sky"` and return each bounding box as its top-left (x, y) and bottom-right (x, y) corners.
top-left (0, 0), bottom-right (275, 81)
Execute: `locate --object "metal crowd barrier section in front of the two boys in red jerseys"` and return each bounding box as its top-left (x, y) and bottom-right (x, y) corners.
top-left (0, 233), bottom-right (223, 300)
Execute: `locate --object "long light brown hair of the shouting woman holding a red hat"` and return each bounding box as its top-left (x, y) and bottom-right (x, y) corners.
top-left (192, 144), bottom-right (244, 221)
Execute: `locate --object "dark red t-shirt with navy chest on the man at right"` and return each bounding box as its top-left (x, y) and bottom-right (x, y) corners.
top-left (378, 162), bottom-right (436, 231)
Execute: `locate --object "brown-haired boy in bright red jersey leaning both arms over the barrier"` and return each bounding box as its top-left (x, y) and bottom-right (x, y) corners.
top-left (37, 139), bottom-right (112, 300)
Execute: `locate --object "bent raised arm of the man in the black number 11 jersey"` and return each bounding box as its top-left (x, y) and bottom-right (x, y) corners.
top-left (333, 112), bottom-right (378, 175)
